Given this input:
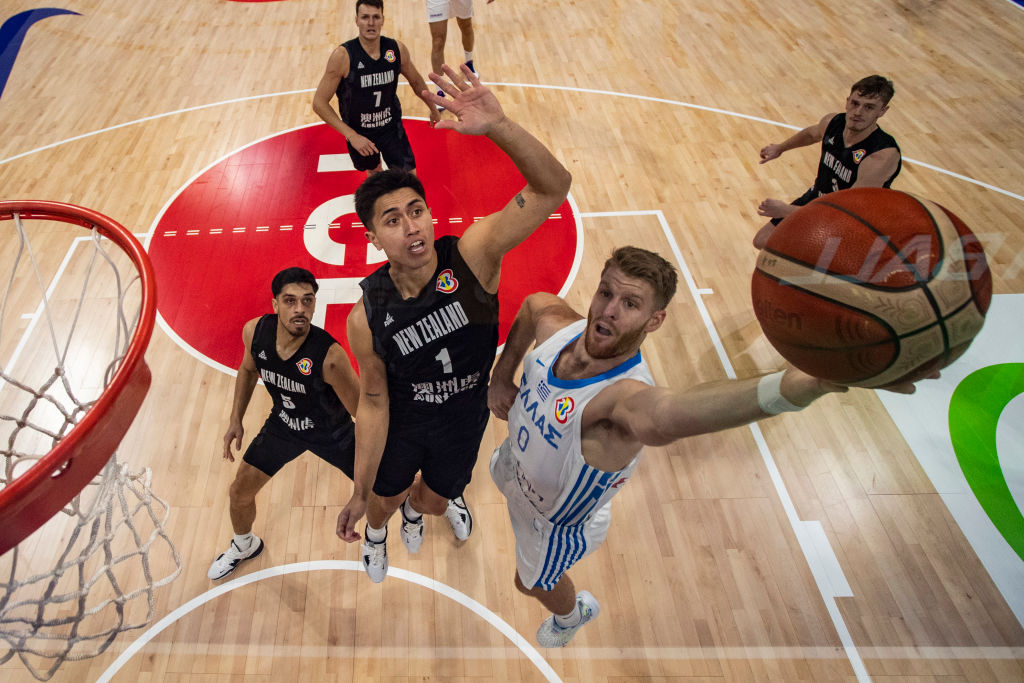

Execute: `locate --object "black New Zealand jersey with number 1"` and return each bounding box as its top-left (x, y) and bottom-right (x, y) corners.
top-left (359, 236), bottom-right (498, 422)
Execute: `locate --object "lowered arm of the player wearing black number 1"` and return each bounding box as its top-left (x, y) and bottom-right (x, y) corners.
top-left (337, 299), bottom-right (390, 543)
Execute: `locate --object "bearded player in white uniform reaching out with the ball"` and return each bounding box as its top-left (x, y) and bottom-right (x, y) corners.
top-left (487, 247), bottom-right (929, 647)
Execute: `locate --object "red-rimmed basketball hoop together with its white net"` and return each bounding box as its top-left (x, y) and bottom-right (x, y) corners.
top-left (0, 202), bottom-right (181, 680)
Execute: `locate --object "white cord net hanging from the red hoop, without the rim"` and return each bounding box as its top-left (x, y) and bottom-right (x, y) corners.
top-left (0, 213), bottom-right (181, 680)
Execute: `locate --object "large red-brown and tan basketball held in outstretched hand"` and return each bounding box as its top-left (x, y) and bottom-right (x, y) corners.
top-left (751, 187), bottom-right (992, 387)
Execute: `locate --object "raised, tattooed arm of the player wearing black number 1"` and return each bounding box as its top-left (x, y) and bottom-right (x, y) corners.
top-left (424, 65), bottom-right (572, 292)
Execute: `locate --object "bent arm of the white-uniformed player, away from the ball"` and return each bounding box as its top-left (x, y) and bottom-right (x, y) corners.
top-left (487, 292), bottom-right (582, 420)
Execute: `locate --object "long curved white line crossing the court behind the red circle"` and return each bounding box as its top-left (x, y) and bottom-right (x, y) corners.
top-left (0, 84), bottom-right (1024, 202)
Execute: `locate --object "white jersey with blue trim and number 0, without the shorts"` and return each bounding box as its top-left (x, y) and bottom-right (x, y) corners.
top-left (509, 319), bottom-right (654, 525)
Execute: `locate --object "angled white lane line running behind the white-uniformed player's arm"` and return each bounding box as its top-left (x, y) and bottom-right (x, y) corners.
top-left (581, 210), bottom-right (871, 682)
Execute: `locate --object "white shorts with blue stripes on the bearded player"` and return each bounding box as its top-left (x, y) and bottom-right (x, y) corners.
top-left (490, 439), bottom-right (611, 591)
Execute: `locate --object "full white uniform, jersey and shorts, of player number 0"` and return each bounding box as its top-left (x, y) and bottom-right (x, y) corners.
top-left (492, 319), bottom-right (654, 590)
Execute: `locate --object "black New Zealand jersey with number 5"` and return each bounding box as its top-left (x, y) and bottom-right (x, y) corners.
top-left (249, 314), bottom-right (352, 441)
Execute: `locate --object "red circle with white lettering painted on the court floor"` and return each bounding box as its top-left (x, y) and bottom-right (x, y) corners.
top-left (146, 120), bottom-right (582, 371)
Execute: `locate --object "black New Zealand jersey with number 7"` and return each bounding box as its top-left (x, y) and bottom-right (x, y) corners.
top-left (338, 36), bottom-right (401, 136)
